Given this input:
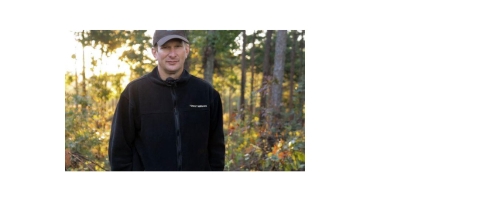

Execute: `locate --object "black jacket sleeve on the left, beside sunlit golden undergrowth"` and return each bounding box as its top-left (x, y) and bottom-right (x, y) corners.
top-left (108, 94), bottom-right (135, 171)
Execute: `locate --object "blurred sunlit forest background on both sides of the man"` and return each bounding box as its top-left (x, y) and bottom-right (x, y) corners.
top-left (64, 30), bottom-right (305, 171)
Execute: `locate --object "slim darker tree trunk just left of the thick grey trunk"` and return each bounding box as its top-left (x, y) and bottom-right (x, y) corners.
top-left (259, 30), bottom-right (273, 125)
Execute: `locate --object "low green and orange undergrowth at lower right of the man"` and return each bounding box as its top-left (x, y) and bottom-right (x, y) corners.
top-left (225, 109), bottom-right (305, 171)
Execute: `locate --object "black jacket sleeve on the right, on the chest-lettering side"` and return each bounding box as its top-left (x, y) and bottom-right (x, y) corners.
top-left (208, 90), bottom-right (225, 171)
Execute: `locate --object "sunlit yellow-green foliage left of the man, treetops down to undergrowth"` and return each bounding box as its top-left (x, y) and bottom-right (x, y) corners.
top-left (65, 30), bottom-right (154, 171)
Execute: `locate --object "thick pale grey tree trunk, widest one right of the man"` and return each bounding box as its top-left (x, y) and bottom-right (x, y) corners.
top-left (268, 30), bottom-right (287, 138)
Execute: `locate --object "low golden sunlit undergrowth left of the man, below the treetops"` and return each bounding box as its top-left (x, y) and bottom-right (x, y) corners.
top-left (65, 70), bottom-right (125, 170)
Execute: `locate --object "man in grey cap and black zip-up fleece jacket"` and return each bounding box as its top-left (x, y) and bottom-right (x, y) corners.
top-left (108, 30), bottom-right (225, 171)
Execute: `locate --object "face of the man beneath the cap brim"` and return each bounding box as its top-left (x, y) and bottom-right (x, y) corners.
top-left (152, 39), bottom-right (190, 75)
